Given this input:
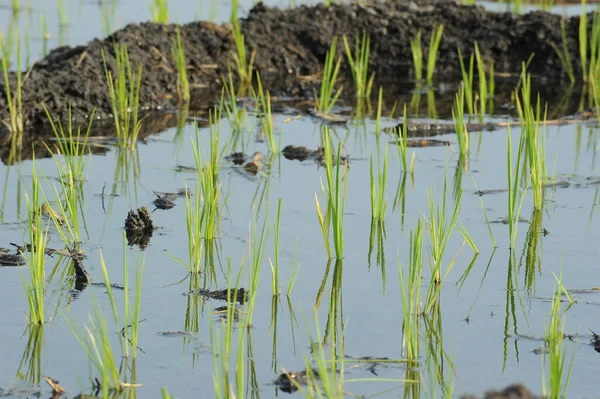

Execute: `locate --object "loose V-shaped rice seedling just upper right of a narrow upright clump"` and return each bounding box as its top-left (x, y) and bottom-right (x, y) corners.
top-left (425, 177), bottom-right (462, 313)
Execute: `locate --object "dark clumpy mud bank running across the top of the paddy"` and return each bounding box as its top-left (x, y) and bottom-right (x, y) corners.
top-left (0, 0), bottom-right (591, 147)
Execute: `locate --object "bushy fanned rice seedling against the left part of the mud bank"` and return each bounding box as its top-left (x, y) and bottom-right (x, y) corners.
top-left (102, 43), bottom-right (142, 149)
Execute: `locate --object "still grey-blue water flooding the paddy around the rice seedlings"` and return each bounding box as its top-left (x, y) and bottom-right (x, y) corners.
top-left (0, 2), bottom-right (600, 398)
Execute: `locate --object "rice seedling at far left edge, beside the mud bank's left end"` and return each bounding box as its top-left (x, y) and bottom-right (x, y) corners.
top-left (0, 31), bottom-right (23, 152)
